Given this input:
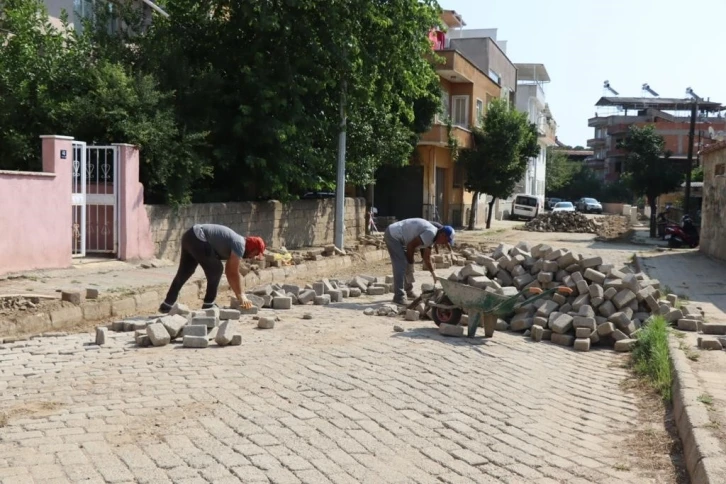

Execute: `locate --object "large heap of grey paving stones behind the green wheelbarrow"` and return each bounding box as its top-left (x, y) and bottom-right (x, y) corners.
top-left (445, 242), bottom-right (691, 351)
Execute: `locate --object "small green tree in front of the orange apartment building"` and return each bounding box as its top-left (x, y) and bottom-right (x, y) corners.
top-left (458, 99), bottom-right (540, 229)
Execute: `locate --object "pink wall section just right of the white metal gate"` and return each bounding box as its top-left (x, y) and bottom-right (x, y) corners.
top-left (114, 144), bottom-right (154, 260)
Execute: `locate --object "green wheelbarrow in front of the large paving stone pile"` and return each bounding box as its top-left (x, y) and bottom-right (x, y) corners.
top-left (428, 278), bottom-right (572, 338)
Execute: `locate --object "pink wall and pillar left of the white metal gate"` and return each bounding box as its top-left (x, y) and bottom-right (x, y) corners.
top-left (0, 136), bottom-right (73, 274)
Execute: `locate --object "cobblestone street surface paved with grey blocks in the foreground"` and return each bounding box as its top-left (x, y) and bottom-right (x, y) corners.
top-left (0, 234), bottom-right (684, 484)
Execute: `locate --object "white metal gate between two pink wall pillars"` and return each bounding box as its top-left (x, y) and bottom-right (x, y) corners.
top-left (72, 142), bottom-right (119, 257)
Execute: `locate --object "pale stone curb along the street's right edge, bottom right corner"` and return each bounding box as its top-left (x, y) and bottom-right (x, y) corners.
top-left (668, 335), bottom-right (726, 484)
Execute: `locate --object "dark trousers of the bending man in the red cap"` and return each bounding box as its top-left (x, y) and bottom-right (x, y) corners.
top-left (164, 229), bottom-right (224, 306)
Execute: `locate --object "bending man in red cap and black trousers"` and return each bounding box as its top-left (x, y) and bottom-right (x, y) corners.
top-left (159, 224), bottom-right (265, 313)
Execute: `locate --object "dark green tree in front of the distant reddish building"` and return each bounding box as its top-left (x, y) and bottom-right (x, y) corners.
top-left (619, 125), bottom-right (684, 237)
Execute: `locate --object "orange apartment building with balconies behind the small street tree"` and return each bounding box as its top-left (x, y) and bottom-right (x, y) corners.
top-left (375, 10), bottom-right (517, 226)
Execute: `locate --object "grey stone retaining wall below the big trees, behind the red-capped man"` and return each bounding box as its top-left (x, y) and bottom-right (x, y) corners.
top-left (146, 198), bottom-right (366, 260)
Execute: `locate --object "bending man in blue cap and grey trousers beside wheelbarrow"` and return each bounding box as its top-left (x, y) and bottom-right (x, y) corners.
top-left (383, 218), bottom-right (454, 304)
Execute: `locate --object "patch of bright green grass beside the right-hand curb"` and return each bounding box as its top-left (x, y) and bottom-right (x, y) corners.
top-left (631, 316), bottom-right (673, 402)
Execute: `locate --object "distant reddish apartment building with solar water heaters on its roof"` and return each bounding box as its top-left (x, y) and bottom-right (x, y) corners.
top-left (585, 97), bottom-right (726, 182)
